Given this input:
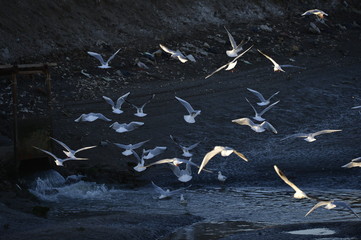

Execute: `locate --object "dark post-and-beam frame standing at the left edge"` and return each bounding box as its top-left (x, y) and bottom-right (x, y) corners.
top-left (0, 63), bottom-right (57, 176)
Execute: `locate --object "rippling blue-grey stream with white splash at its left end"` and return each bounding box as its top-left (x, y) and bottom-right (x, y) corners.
top-left (29, 172), bottom-right (361, 239)
